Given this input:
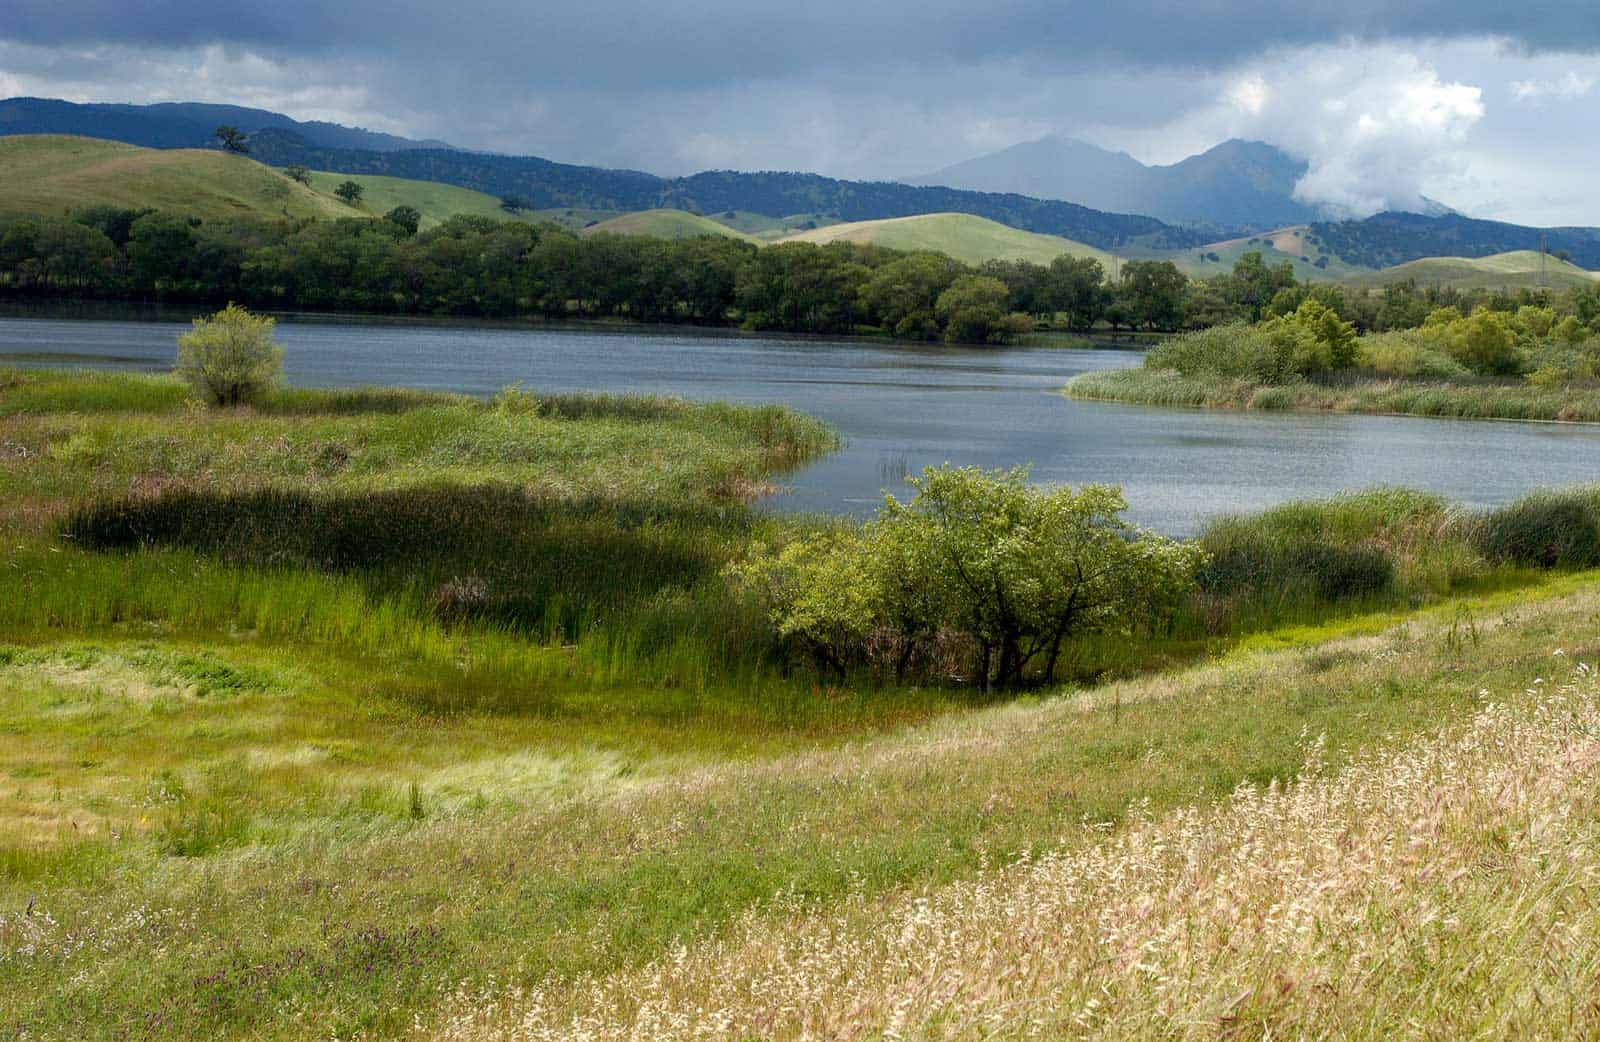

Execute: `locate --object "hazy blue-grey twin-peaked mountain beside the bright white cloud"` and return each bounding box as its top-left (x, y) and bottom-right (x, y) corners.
top-left (907, 136), bottom-right (1334, 230)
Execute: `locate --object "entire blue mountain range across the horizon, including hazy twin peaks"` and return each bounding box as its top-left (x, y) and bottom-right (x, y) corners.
top-left (0, 98), bottom-right (1600, 269)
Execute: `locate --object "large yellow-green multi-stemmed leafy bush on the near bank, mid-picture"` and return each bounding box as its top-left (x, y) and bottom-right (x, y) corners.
top-left (738, 466), bottom-right (1203, 691)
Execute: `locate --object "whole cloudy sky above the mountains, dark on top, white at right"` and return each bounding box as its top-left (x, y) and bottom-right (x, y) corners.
top-left (0, 0), bottom-right (1600, 226)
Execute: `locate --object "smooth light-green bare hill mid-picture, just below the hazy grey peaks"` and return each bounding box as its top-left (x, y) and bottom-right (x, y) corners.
top-left (781, 213), bottom-right (1114, 271)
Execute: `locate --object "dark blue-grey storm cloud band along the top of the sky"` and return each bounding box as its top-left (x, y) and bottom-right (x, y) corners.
top-left (9, 0), bottom-right (1600, 90)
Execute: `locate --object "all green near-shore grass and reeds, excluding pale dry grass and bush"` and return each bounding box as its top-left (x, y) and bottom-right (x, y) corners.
top-left (9, 370), bottom-right (1600, 1039)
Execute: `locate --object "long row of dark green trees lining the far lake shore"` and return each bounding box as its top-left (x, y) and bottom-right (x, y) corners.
top-left (0, 206), bottom-right (1184, 343)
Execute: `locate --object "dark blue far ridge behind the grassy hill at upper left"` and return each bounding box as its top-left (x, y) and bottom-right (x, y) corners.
top-left (0, 98), bottom-right (450, 152)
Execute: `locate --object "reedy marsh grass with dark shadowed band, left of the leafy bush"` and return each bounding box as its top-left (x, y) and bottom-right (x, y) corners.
top-left (0, 366), bottom-right (835, 707)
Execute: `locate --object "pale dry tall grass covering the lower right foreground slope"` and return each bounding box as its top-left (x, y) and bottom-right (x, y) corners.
top-left (418, 658), bottom-right (1600, 1042)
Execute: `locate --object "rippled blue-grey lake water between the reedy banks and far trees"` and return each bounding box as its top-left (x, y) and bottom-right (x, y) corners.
top-left (0, 319), bottom-right (1600, 535)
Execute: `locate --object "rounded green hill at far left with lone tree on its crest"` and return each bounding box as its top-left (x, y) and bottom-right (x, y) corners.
top-left (0, 134), bottom-right (349, 218)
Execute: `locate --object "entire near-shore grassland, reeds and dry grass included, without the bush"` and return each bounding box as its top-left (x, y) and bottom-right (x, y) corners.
top-left (9, 352), bottom-right (1600, 1040)
